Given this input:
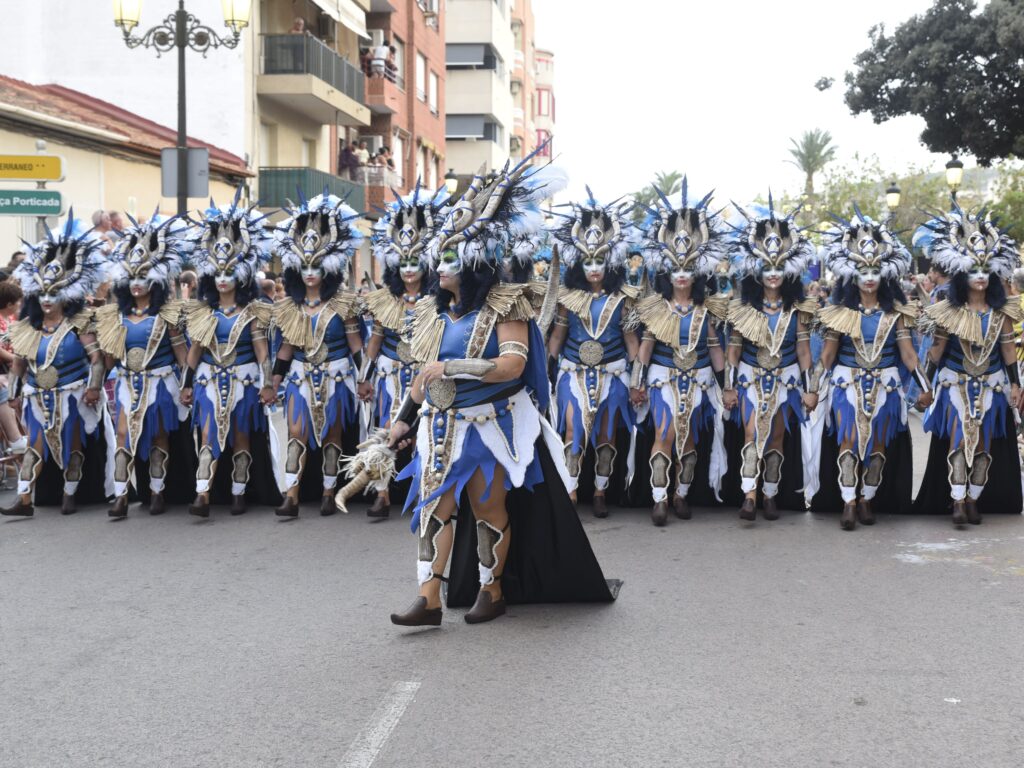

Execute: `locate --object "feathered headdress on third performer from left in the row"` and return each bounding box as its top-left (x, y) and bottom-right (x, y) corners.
top-left (189, 186), bottom-right (273, 285)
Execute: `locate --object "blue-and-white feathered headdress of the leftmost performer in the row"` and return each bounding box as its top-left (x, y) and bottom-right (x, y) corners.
top-left (13, 210), bottom-right (106, 304)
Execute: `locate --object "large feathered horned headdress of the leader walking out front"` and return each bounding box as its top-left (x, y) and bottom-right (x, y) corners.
top-left (427, 144), bottom-right (567, 269)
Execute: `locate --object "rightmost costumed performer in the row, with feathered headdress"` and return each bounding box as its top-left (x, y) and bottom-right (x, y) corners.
top-left (914, 200), bottom-right (1022, 526)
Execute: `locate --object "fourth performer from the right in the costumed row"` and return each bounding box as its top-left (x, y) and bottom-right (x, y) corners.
top-left (631, 179), bottom-right (729, 525)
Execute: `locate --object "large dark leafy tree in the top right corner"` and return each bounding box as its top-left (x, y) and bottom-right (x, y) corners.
top-left (846, 0), bottom-right (1024, 165)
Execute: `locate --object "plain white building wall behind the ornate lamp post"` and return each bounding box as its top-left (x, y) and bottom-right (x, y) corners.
top-left (0, 0), bottom-right (249, 157)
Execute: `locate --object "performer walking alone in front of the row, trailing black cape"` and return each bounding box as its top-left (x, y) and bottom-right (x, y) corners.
top-left (376, 156), bottom-right (612, 626)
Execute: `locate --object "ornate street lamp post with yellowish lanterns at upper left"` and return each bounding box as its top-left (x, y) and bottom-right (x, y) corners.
top-left (114, 0), bottom-right (252, 215)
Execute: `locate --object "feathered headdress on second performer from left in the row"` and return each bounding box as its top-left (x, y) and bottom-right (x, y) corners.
top-left (110, 208), bottom-right (194, 287)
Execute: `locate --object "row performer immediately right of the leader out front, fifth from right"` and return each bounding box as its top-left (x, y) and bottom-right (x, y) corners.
top-left (548, 187), bottom-right (640, 517)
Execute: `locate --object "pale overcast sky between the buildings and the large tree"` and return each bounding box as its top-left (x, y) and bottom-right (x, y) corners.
top-left (532, 0), bottom-right (958, 203)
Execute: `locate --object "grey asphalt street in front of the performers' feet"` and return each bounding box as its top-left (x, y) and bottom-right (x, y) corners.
top-left (0, 421), bottom-right (1024, 768)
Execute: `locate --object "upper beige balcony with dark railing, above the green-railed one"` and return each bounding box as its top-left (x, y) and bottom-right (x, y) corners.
top-left (256, 35), bottom-right (370, 126)
